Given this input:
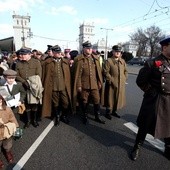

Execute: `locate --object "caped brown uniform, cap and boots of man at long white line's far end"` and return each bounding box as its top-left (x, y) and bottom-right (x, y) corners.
top-left (42, 46), bottom-right (72, 125)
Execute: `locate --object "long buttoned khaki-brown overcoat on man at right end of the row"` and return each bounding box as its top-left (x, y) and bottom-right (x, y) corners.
top-left (103, 57), bottom-right (128, 110)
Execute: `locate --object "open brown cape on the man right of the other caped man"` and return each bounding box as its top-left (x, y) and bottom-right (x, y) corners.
top-left (73, 54), bottom-right (103, 111)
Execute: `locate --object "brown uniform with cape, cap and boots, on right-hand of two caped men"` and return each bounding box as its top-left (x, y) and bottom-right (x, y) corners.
top-left (73, 42), bottom-right (104, 123)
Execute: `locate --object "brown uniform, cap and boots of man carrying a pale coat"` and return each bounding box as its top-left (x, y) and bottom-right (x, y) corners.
top-left (16, 48), bottom-right (42, 128)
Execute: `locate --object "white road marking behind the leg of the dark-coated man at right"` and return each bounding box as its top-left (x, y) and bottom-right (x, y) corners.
top-left (124, 122), bottom-right (165, 152)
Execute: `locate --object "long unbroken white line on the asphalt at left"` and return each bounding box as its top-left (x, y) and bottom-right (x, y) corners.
top-left (13, 121), bottom-right (54, 170)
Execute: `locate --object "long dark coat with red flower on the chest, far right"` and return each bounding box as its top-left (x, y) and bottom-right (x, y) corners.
top-left (136, 54), bottom-right (170, 138)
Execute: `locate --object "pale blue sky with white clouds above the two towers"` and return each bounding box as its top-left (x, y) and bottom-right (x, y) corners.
top-left (0, 0), bottom-right (170, 51)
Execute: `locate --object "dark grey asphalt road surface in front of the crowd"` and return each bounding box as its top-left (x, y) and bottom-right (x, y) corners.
top-left (1, 66), bottom-right (170, 170)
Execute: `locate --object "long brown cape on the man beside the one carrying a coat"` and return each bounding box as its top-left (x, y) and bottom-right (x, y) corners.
top-left (42, 58), bottom-right (71, 117)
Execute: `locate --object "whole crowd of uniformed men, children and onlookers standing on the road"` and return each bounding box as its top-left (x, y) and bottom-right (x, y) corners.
top-left (0, 38), bottom-right (170, 168)
